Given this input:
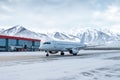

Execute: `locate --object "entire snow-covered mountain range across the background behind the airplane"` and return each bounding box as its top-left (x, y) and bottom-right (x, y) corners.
top-left (0, 25), bottom-right (120, 44)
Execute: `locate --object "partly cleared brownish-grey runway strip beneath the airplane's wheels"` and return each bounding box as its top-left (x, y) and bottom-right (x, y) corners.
top-left (0, 50), bottom-right (120, 61)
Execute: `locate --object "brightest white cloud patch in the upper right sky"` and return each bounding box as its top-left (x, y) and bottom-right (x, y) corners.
top-left (94, 5), bottom-right (120, 24)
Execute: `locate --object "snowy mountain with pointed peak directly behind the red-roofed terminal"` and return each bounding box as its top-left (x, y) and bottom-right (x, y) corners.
top-left (0, 25), bottom-right (49, 39)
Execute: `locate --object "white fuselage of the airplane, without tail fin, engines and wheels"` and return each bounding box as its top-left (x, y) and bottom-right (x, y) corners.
top-left (40, 41), bottom-right (85, 51)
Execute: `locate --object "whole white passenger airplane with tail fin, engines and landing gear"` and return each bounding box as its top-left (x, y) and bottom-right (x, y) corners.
top-left (40, 33), bottom-right (86, 56)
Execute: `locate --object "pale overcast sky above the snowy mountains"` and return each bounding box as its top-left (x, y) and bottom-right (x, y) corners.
top-left (0, 0), bottom-right (120, 32)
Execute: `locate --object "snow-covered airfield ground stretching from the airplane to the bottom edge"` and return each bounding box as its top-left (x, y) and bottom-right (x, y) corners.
top-left (0, 51), bottom-right (120, 80)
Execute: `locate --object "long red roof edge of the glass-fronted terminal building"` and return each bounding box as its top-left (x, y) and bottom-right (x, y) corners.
top-left (0, 35), bottom-right (41, 41)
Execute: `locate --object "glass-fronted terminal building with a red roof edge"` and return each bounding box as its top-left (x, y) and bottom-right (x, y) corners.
top-left (0, 35), bottom-right (40, 51)
